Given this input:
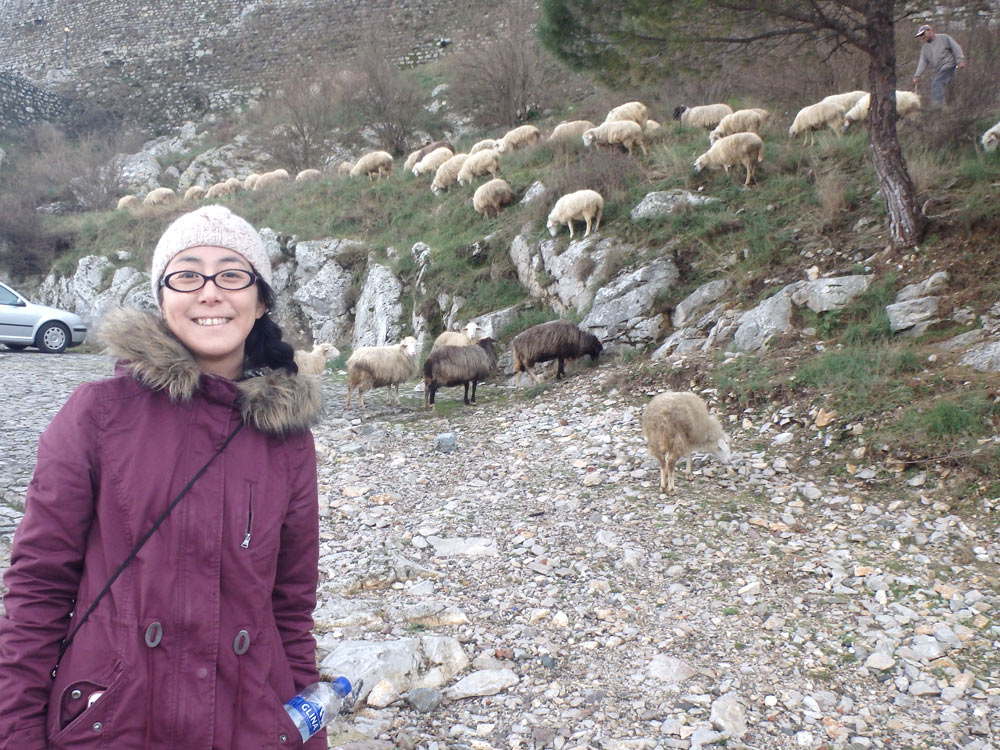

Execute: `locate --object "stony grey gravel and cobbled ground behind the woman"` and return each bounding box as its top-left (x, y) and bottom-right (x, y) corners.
top-left (0, 352), bottom-right (1000, 750)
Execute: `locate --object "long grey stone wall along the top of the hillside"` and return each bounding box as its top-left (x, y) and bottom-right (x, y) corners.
top-left (0, 0), bottom-right (497, 129)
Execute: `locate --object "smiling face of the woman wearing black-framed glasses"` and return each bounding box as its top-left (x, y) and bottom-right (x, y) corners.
top-left (160, 245), bottom-right (266, 380)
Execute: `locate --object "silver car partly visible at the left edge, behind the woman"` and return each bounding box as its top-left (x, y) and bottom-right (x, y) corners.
top-left (0, 281), bottom-right (87, 354)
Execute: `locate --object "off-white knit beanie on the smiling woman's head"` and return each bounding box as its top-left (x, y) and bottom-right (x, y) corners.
top-left (149, 205), bottom-right (271, 300)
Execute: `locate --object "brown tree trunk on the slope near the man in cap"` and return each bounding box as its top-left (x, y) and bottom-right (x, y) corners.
top-left (866, 0), bottom-right (926, 249)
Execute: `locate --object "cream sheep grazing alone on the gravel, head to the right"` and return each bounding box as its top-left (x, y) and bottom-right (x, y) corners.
top-left (642, 392), bottom-right (731, 494)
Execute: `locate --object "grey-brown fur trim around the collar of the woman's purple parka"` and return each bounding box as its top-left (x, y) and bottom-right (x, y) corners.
top-left (99, 308), bottom-right (322, 437)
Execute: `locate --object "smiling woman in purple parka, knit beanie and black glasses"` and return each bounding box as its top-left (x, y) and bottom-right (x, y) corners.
top-left (0, 206), bottom-right (326, 750)
